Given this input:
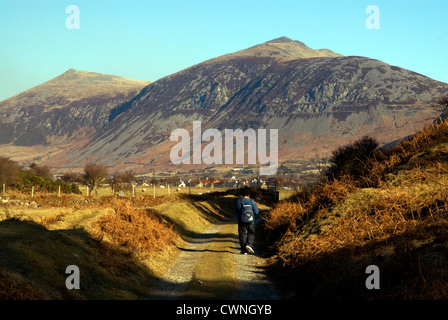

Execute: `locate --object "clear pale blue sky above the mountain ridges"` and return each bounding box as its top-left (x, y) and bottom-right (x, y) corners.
top-left (0, 0), bottom-right (448, 101)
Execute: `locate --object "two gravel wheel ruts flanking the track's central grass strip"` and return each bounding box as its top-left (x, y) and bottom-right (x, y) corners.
top-left (147, 219), bottom-right (280, 300)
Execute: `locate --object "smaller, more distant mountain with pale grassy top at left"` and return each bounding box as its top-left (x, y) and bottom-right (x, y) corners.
top-left (0, 69), bottom-right (149, 146)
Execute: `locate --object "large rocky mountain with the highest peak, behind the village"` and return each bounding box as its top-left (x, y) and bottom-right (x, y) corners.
top-left (0, 37), bottom-right (448, 172)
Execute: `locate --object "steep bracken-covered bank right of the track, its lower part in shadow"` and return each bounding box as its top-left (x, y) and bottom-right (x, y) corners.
top-left (266, 118), bottom-right (448, 299)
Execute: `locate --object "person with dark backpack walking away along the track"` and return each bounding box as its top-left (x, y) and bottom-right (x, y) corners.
top-left (235, 190), bottom-right (259, 254)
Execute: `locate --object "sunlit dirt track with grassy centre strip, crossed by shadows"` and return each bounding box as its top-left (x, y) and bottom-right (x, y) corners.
top-left (148, 219), bottom-right (280, 300)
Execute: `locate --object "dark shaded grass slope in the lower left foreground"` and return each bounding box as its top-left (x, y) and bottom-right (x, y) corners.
top-left (0, 219), bottom-right (158, 299)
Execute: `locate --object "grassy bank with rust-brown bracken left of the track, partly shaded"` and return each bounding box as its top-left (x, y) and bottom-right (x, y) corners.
top-left (0, 190), bottom-right (233, 299)
